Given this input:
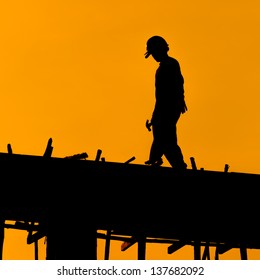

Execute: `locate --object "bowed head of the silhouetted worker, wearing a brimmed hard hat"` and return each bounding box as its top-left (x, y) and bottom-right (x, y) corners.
top-left (145, 35), bottom-right (169, 61)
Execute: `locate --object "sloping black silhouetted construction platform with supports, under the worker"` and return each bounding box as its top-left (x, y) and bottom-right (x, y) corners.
top-left (0, 149), bottom-right (260, 260)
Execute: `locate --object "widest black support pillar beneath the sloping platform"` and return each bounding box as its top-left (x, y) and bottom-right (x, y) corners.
top-left (46, 207), bottom-right (97, 260)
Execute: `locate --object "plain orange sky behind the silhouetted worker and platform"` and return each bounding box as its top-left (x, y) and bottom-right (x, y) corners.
top-left (0, 0), bottom-right (260, 258)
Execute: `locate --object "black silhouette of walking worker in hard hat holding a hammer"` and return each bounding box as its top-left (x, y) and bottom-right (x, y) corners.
top-left (145, 36), bottom-right (187, 169)
